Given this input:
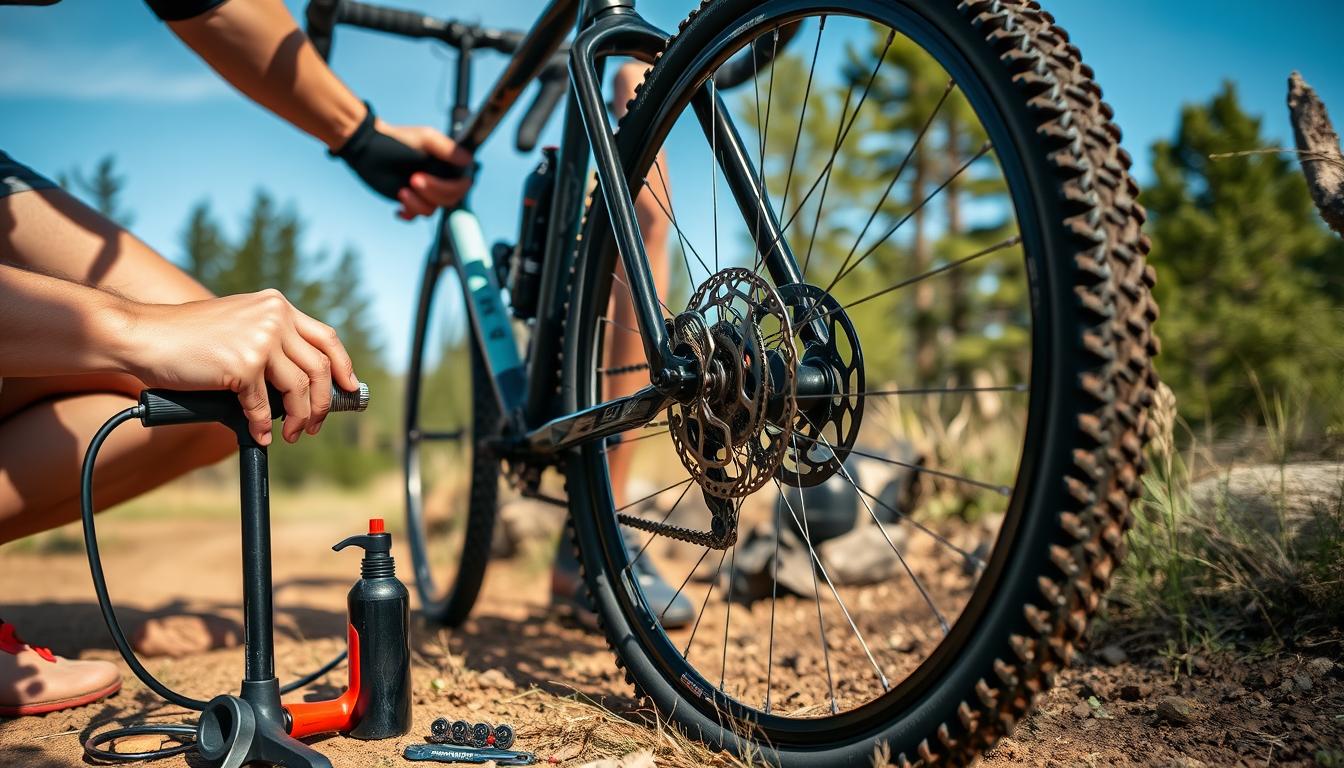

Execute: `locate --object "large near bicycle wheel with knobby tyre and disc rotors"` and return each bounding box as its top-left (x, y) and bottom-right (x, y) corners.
top-left (566, 0), bottom-right (1157, 765)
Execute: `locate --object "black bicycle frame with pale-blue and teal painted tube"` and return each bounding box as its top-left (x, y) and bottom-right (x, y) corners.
top-left (407, 0), bottom-right (802, 456)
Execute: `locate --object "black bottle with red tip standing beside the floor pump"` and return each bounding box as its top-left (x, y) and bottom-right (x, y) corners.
top-left (332, 518), bottom-right (411, 738)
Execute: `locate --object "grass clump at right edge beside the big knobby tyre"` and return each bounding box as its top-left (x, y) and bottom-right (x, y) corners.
top-left (1111, 387), bottom-right (1344, 658)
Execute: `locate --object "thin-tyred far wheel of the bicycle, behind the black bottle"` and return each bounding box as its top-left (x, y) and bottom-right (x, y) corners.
top-left (402, 248), bottom-right (500, 627)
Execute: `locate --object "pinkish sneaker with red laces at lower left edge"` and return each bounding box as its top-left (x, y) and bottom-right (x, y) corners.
top-left (0, 621), bottom-right (121, 717)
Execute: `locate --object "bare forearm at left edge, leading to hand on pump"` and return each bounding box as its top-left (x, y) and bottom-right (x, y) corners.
top-left (0, 264), bottom-right (136, 378)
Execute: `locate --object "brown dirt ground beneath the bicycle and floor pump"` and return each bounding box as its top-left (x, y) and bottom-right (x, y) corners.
top-left (0, 507), bottom-right (1344, 768)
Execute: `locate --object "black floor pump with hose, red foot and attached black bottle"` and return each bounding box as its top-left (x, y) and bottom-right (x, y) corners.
top-left (81, 385), bottom-right (411, 768)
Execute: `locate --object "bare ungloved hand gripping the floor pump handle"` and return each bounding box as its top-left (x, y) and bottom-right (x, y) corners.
top-left (130, 289), bottom-right (359, 445)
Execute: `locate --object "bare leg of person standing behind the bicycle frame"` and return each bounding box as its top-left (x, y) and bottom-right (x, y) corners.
top-left (603, 62), bottom-right (671, 506)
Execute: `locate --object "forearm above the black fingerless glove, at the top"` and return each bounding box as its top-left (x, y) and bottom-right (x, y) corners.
top-left (169, 0), bottom-right (366, 149)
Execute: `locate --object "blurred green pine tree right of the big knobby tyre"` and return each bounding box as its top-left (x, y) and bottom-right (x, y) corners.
top-left (1144, 83), bottom-right (1344, 424)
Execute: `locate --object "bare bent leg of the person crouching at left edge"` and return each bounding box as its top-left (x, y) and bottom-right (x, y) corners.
top-left (0, 190), bottom-right (234, 543)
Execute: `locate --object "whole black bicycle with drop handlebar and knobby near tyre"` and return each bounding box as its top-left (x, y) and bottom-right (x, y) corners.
top-left (308, 0), bottom-right (1157, 765)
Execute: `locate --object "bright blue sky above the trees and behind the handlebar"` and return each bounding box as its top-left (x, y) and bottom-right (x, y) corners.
top-left (0, 0), bottom-right (1344, 369)
